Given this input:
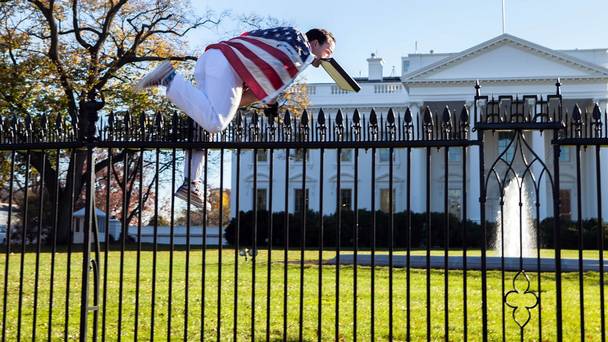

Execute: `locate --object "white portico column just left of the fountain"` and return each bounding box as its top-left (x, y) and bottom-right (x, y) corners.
top-left (463, 101), bottom-right (481, 222)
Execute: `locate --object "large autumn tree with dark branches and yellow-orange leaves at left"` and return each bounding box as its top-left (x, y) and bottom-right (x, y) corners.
top-left (0, 0), bottom-right (222, 242)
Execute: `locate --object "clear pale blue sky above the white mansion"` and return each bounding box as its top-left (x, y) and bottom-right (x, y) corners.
top-left (189, 0), bottom-right (608, 187)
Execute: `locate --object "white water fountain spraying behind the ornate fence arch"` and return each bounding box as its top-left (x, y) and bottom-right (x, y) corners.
top-left (494, 177), bottom-right (536, 257)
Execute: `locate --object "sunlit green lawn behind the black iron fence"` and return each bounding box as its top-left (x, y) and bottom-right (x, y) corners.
top-left (0, 249), bottom-right (600, 341)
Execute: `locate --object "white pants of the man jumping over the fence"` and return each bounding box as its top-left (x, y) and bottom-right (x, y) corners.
top-left (167, 49), bottom-right (243, 181)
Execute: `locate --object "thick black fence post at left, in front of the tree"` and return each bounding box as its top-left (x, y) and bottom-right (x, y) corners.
top-left (80, 99), bottom-right (107, 341)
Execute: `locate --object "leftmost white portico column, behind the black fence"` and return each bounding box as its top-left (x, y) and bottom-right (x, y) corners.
top-left (410, 102), bottom-right (429, 213)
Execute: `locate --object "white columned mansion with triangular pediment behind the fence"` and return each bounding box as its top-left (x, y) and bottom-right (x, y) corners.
top-left (231, 34), bottom-right (608, 221)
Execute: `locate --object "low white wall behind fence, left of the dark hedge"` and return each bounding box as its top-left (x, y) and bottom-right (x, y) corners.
top-left (129, 226), bottom-right (228, 246)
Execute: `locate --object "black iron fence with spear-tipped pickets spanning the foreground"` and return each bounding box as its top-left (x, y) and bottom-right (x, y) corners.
top-left (0, 82), bottom-right (608, 341)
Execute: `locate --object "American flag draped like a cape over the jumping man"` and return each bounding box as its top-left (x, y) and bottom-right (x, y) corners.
top-left (207, 27), bottom-right (314, 102)
